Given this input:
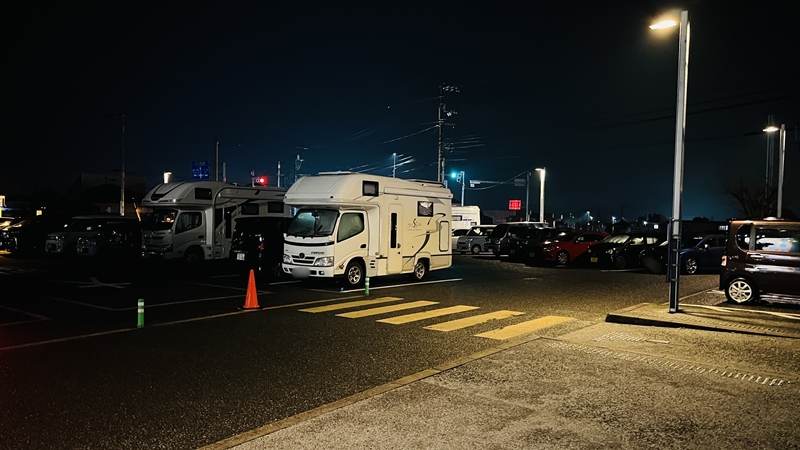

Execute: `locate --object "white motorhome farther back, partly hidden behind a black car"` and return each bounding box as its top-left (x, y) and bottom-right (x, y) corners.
top-left (141, 181), bottom-right (291, 265)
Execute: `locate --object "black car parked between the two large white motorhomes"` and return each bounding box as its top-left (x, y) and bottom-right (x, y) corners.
top-left (230, 216), bottom-right (292, 278)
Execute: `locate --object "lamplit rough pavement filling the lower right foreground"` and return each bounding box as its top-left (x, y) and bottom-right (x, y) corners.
top-left (204, 303), bottom-right (800, 450)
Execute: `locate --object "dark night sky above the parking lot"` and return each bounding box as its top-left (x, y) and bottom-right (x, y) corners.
top-left (0, 0), bottom-right (800, 220)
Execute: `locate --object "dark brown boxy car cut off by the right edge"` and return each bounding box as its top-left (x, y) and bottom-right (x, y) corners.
top-left (719, 219), bottom-right (800, 303)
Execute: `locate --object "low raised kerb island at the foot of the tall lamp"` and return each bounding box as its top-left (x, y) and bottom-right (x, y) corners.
top-left (606, 303), bottom-right (800, 339)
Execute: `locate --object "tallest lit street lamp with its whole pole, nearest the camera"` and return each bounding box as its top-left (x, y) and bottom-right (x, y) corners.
top-left (650, 11), bottom-right (689, 313)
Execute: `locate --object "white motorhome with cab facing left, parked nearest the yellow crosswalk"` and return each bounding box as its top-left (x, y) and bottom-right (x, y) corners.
top-left (283, 172), bottom-right (453, 286)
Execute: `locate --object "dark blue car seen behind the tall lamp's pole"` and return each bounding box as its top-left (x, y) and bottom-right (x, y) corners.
top-left (642, 234), bottom-right (726, 275)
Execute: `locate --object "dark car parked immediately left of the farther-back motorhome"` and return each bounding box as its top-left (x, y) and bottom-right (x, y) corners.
top-left (76, 220), bottom-right (142, 259)
